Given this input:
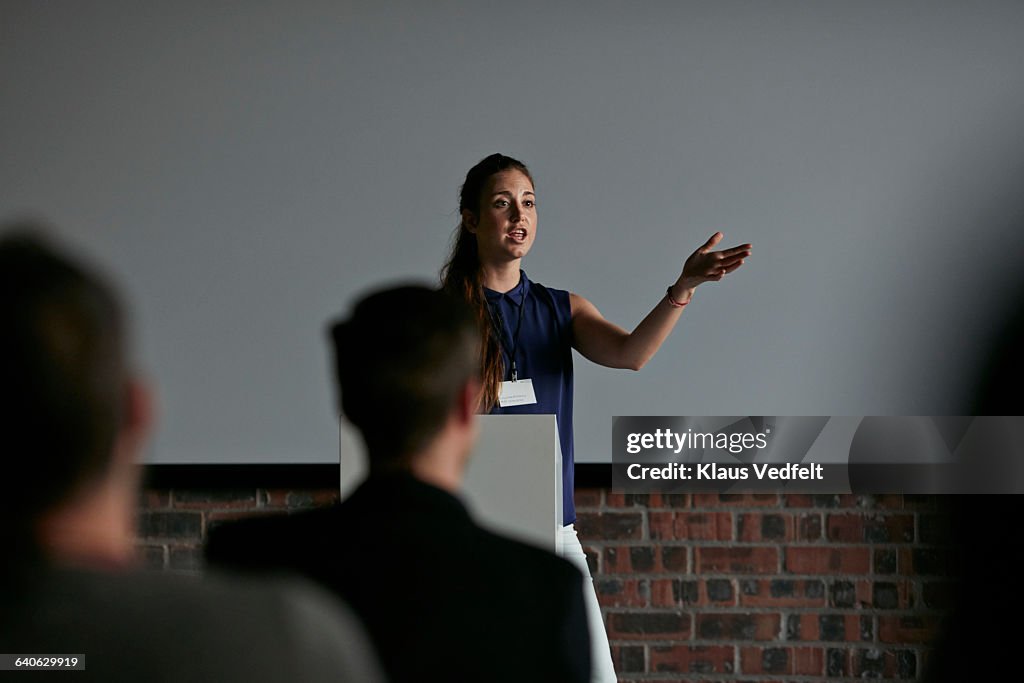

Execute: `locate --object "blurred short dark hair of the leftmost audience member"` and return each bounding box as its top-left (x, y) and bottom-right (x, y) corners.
top-left (0, 223), bottom-right (127, 531)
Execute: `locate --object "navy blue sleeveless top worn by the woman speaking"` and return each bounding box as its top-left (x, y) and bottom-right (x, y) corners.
top-left (483, 270), bottom-right (575, 524)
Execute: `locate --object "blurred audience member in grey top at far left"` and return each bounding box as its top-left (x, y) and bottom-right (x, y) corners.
top-left (0, 226), bottom-right (381, 683)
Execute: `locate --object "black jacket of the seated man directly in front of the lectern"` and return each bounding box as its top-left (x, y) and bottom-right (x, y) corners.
top-left (207, 476), bottom-right (590, 683)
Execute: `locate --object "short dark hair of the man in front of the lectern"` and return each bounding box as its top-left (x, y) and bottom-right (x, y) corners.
top-left (330, 286), bottom-right (480, 469)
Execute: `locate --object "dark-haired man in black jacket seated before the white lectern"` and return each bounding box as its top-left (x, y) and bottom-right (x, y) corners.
top-left (208, 287), bottom-right (590, 683)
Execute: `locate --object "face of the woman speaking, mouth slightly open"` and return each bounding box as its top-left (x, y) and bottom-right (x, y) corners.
top-left (463, 169), bottom-right (537, 263)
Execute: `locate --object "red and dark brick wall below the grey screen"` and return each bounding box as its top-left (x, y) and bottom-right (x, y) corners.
top-left (139, 488), bottom-right (953, 683)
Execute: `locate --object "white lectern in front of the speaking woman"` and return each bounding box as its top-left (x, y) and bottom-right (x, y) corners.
top-left (340, 415), bottom-right (562, 552)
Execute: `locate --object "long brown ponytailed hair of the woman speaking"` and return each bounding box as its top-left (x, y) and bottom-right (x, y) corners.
top-left (441, 154), bottom-right (534, 413)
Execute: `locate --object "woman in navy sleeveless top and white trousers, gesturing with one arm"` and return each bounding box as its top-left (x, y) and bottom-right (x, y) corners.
top-left (441, 154), bottom-right (751, 682)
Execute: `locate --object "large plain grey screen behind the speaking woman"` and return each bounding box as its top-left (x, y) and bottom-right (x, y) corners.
top-left (0, 0), bottom-right (1024, 463)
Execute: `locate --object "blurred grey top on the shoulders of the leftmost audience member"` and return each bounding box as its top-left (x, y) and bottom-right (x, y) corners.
top-left (0, 564), bottom-right (377, 683)
